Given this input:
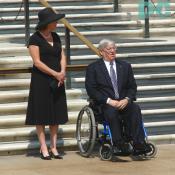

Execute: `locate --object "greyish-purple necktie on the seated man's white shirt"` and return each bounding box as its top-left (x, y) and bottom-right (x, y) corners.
top-left (110, 62), bottom-right (119, 99)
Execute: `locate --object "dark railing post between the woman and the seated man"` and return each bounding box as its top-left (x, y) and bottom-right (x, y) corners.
top-left (65, 27), bottom-right (71, 89)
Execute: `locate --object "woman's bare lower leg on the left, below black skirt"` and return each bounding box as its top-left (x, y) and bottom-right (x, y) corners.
top-left (36, 125), bottom-right (49, 157)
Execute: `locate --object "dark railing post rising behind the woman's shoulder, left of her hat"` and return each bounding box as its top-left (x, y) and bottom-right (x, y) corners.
top-left (23, 0), bottom-right (30, 45)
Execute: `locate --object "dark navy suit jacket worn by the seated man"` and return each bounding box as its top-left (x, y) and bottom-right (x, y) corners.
top-left (85, 58), bottom-right (137, 104)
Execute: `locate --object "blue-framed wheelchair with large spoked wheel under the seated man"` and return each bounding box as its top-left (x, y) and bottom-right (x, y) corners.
top-left (76, 102), bottom-right (157, 160)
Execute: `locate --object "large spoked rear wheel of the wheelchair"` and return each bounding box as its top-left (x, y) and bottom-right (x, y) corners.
top-left (76, 106), bottom-right (96, 157)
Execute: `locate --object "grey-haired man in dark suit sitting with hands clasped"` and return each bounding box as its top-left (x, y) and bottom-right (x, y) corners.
top-left (85, 39), bottom-right (151, 155)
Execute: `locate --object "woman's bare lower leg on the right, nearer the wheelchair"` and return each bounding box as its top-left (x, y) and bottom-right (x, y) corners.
top-left (49, 125), bottom-right (58, 155)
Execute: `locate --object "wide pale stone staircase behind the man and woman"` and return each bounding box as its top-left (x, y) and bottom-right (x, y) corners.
top-left (0, 0), bottom-right (175, 155)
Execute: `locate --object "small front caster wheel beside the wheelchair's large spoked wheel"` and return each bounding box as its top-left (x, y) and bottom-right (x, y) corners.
top-left (99, 143), bottom-right (113, 160)
